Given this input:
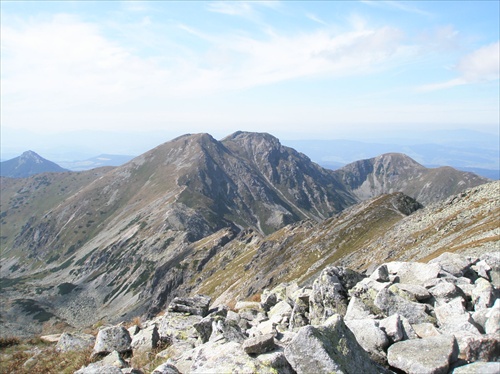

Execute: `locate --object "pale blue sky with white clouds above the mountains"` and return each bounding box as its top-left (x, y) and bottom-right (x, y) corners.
top-left (0, 0), bottom-right (500, 159)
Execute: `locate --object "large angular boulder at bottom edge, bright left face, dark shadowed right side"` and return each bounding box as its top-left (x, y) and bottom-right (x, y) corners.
top-left (285, 315), bottom-right (382, 374)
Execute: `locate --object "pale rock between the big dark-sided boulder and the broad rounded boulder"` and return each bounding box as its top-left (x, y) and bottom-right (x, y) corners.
top-left (344, 319), bottom-right (389, 365)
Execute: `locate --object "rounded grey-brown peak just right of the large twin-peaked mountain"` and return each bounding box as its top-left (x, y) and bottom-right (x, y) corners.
top-left (334, 153), bottom-right (490, 205)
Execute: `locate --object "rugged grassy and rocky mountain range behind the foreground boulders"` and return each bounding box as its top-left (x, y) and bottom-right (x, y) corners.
top-left (0, 132), bottom-right (499, 334)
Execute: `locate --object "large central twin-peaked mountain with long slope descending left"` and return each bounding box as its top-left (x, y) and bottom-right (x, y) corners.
top-left (0, 132), bottom-right (494, 336)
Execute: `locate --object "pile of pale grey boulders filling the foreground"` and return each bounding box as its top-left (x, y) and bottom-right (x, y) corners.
top-left (32, 253), bottom-right (500, 374)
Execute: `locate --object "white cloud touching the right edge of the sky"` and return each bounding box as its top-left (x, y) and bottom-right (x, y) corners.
top-left (418, 42), bottom-right (500, 92)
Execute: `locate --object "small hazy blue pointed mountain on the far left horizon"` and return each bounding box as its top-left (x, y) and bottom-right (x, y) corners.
top-left (0, 151), bottom-right (68, 178)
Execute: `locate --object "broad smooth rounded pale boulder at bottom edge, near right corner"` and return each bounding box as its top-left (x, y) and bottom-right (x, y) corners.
top-left (387, 336), bottom-right (458, 374)
